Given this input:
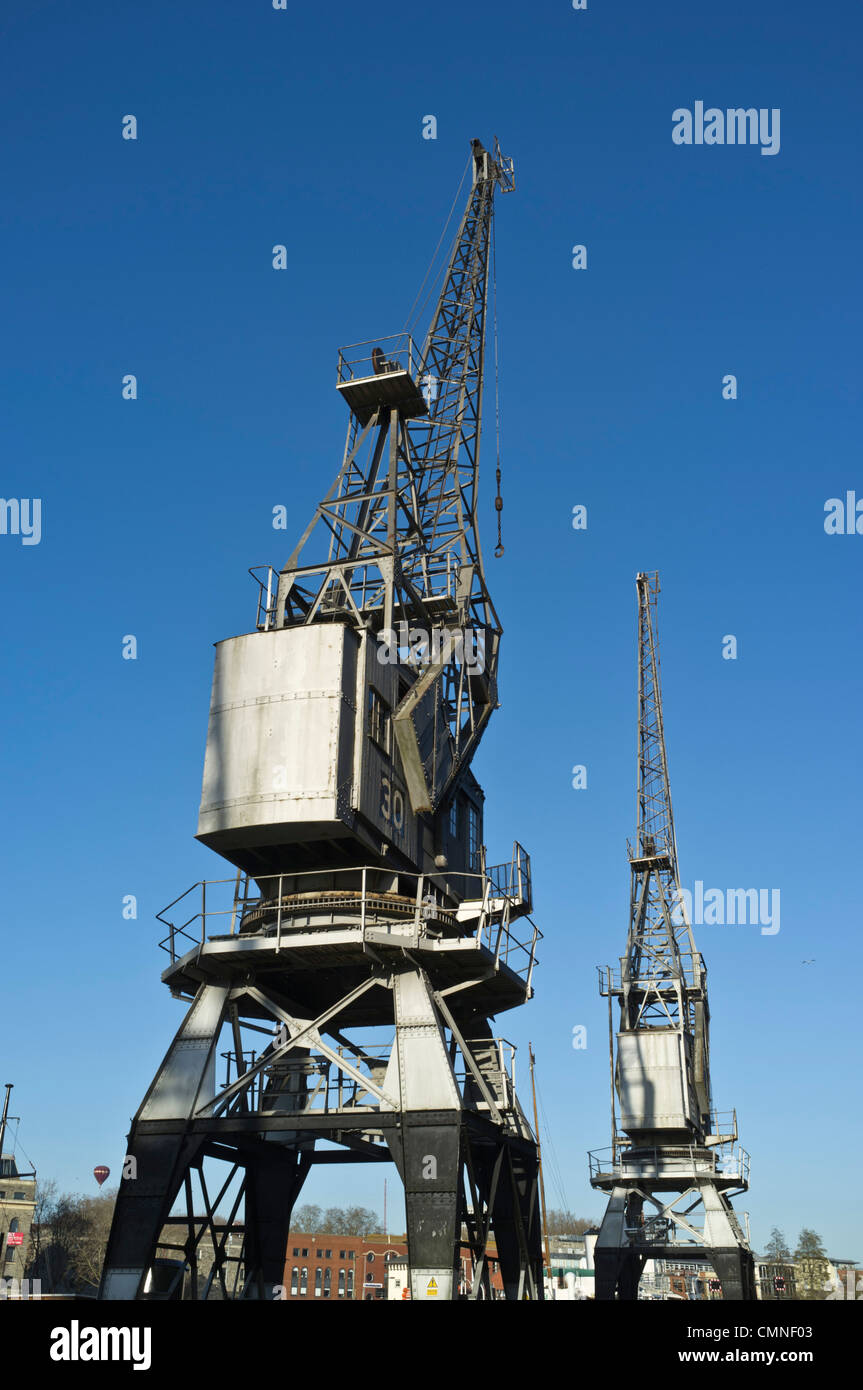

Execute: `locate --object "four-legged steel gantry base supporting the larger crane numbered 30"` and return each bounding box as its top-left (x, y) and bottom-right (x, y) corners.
top-left (103, 888), bottom-right (542, 1301)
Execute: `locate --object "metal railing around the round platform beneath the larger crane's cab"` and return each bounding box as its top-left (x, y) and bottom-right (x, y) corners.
top-left (156, 847), bottom-right (542, 990)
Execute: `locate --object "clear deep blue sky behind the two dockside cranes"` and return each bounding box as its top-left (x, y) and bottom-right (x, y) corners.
top-left (0, 0), bottom-right (863, 1258)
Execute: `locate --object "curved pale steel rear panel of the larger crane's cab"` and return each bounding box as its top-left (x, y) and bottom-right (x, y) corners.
top-left (197, 623), bottom-right (359, 848)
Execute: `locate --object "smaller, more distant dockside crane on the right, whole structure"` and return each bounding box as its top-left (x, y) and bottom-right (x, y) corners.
top-left (589, 574), bottom-right (756, 1300)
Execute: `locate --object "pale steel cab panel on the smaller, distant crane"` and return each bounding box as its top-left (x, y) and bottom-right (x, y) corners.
top-left (617, 1029), bottom-right (698, 1133)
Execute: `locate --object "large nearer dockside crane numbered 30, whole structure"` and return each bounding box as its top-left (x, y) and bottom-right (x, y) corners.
top-left (100, 140), bottom-right (542, 1302)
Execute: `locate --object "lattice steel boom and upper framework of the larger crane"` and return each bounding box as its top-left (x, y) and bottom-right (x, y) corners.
top-left (267, 140), bottom-right (514, 813)
